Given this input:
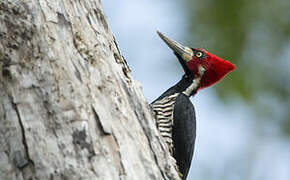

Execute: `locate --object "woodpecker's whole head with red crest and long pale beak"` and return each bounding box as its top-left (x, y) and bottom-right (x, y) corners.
top-left (157, 31), bottom-right (235, 90)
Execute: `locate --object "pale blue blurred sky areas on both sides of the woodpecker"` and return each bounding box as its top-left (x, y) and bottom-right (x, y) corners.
top-left (102, 0), bottom-right (290, 180)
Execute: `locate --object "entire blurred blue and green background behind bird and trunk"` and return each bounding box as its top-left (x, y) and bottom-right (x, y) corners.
top-left (103, 0), bottom-right (290, 180)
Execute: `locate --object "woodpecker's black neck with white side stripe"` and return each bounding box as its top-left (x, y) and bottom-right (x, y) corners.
top-left (154, 73), bottom-right (200, 102)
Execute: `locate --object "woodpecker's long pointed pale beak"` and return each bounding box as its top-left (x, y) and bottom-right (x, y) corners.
top-left (157, 31), bottom-right (193, 62)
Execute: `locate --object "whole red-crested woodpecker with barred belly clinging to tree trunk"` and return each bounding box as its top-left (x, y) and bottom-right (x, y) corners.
top-left (151, 32), bottom-right (235, 180)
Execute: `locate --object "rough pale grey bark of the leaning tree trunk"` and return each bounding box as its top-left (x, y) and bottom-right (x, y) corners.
top-left (0, 0), bottom-right (178, 180)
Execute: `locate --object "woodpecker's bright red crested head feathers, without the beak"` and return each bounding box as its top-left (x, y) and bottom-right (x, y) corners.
top-left (186, 49), bottom-right (235, 90)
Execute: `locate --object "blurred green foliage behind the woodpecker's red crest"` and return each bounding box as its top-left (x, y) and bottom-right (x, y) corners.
top-left (186, 0), bottom-right (290, 135)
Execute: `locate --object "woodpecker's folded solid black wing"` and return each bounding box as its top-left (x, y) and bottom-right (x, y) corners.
top-left (172, 93), bottom-right (196, 179)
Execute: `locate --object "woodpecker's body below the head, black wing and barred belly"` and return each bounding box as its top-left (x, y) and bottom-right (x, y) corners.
top-left (152, 54), bottom-right (196, 180)
